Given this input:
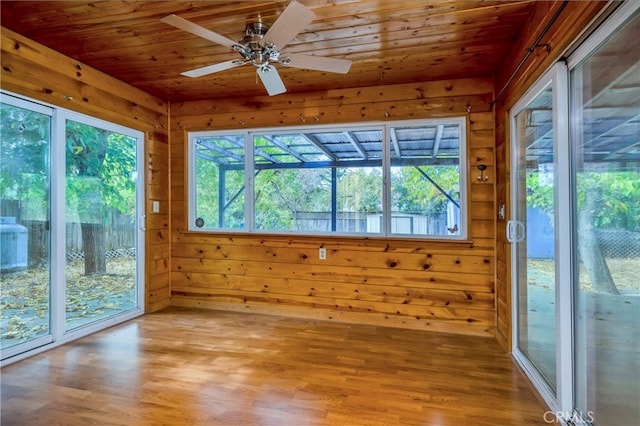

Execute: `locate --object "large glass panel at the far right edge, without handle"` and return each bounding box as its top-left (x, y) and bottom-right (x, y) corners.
top-left (571, 9), bottom-right (640, 425)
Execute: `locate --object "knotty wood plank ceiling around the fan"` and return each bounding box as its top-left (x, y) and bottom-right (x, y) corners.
top-left (0, 0), bottom-right (533, 101)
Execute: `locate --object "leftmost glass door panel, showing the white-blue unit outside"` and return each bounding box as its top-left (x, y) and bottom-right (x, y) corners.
top-left (0, 96), bottom-right (52, 358)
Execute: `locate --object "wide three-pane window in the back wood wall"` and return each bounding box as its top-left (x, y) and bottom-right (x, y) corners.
top-left (189, 118), bottom-right (466, 239)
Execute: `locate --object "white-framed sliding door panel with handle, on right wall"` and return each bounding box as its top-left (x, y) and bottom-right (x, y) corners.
top-left (508, 64), bottom-right (570, 401)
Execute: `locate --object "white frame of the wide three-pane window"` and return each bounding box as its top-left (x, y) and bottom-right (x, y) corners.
top-left (185, 116), bottom-right (469, 241)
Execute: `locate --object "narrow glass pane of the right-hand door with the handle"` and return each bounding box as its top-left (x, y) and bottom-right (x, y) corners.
top-left (514, 83), bottom-right (556, 390)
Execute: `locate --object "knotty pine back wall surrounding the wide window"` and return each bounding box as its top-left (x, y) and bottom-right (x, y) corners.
top-left (170, 78), bottom-right (496, 336)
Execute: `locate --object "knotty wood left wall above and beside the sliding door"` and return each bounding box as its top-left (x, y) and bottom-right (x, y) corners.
top-left (0, 27), bottom-right (171, 312)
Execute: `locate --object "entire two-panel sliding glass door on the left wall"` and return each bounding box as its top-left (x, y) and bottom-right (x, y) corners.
top-left (0, 92), bottom-right (144, 362)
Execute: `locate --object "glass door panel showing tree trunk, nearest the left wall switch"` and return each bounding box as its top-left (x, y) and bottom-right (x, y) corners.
top-left (65, 120), bottom-right (138, 331)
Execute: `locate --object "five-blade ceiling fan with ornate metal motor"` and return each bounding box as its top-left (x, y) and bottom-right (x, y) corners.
top-left (161, 1), bottom-right (351, 96)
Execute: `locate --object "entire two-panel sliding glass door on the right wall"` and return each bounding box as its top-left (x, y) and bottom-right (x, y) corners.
top-left (507, 2), bottom-right (640, 426)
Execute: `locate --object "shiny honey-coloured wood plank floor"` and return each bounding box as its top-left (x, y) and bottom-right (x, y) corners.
top-left (1, 308), bottom-right (547, 426)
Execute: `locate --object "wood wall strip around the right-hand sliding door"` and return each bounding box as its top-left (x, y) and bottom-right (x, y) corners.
top-left (495, 1), bottom-right (608, 351)
